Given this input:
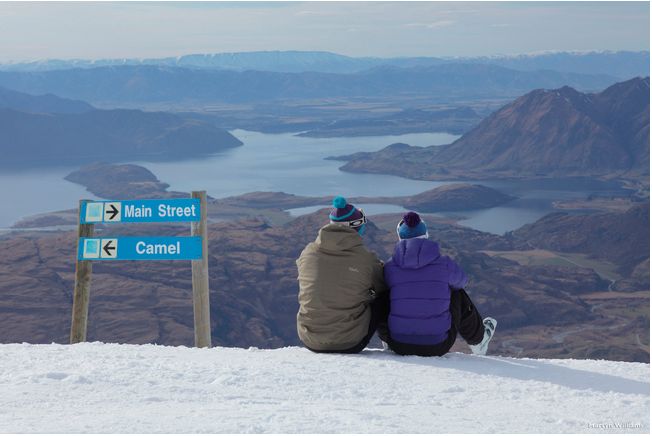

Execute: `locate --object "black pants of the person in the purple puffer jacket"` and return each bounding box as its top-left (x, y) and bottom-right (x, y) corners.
top-left (378, 289), bottom-right (484, 356)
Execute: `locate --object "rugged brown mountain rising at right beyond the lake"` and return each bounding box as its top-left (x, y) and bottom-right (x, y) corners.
top-left (342, 77), bottom-right (650, 179)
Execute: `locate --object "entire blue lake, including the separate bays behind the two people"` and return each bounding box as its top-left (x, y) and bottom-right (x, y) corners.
top-left (0, 130), bottom-right (623, 234)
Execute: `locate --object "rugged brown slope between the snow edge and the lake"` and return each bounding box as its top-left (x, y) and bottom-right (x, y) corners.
top-left (0, 203), bottom-right (649, 362)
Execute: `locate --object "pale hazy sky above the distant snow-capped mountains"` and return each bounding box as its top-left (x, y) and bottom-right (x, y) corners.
top-left (0, 2), bottom-right (650, 62)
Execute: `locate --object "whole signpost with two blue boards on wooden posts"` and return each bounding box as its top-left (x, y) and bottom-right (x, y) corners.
top-left (70, 191), bottom-right (211, 347)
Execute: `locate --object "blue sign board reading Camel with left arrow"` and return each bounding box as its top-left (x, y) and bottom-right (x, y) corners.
top-left (77, 236), bottom-right (202, 260)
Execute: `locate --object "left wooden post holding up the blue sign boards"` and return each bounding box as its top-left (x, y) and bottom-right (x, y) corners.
top-left (70, 200), bottom-right (95, 344)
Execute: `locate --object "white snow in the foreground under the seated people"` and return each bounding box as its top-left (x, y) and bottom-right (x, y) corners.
top-left (0, 343), bottom-right (650, 433)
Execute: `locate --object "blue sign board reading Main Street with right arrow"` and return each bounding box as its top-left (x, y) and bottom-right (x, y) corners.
top-left (80, 198), bottom-right (201, 224)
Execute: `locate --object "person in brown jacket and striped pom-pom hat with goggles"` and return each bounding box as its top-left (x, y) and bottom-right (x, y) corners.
top-left (297, 197), bottom-right (389, 353)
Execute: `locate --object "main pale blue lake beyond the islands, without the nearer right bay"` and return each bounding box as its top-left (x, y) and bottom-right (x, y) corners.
top-left (0, 130), bottom-right (457, 229)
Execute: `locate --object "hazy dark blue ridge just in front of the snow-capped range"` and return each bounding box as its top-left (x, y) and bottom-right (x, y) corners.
top-left (0, 63), bottom-right (616, 106)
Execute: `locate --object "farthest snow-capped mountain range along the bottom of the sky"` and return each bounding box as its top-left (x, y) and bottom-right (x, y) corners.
top-left (0, 50), bottom-right (650, 79)
